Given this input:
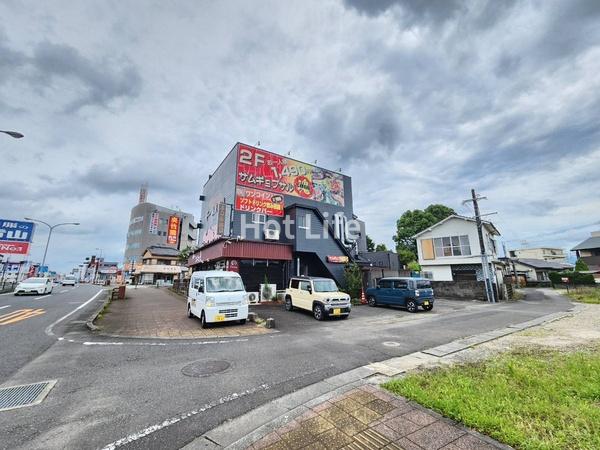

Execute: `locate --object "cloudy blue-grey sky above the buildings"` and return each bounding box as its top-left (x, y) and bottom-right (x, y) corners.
top-left (0, 0), bottom-right (600, 270)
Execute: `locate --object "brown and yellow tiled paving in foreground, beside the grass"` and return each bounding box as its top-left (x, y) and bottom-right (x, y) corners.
top-left (250, 385), bottom-right (507, 450)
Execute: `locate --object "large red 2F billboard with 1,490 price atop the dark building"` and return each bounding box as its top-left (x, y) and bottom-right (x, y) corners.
top-left (237, 144), bottom-right (344, 206)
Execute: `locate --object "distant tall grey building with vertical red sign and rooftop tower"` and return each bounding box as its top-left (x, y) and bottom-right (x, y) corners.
top-left (124, 186), bottom-right (198, 272)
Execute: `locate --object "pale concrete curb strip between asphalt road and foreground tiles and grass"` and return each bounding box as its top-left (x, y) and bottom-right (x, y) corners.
top-left (183, 305), bottom-right (584, 450)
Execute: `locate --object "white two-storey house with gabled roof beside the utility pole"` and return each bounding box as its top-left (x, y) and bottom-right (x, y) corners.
top-left (413, 215), bottom-right (503, 284)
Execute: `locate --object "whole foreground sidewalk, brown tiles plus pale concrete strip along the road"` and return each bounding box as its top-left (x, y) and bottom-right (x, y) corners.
top-left (184, 298), bottom-right (582, 450)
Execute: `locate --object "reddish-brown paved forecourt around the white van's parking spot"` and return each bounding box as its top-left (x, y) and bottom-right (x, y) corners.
top-left (96, 286), bottom-right (271, 339)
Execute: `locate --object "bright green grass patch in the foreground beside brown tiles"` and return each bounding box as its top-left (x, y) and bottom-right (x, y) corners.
top-left (383, 348), bottom-right (600, 449)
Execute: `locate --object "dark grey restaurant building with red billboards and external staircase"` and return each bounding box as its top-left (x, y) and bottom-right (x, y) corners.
top-left (188, 143), bottom-right (366, 291)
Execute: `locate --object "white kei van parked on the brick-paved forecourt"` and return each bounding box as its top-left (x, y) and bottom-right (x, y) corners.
top-left (187, 270), bottom-right (248, 328)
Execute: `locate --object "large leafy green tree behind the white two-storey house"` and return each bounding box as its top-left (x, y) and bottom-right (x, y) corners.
top-left (393, 204), bottom-right (456, 264)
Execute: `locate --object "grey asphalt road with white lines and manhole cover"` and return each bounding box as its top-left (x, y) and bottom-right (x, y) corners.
top-left (0, 286), bottom-right (571, 449)
